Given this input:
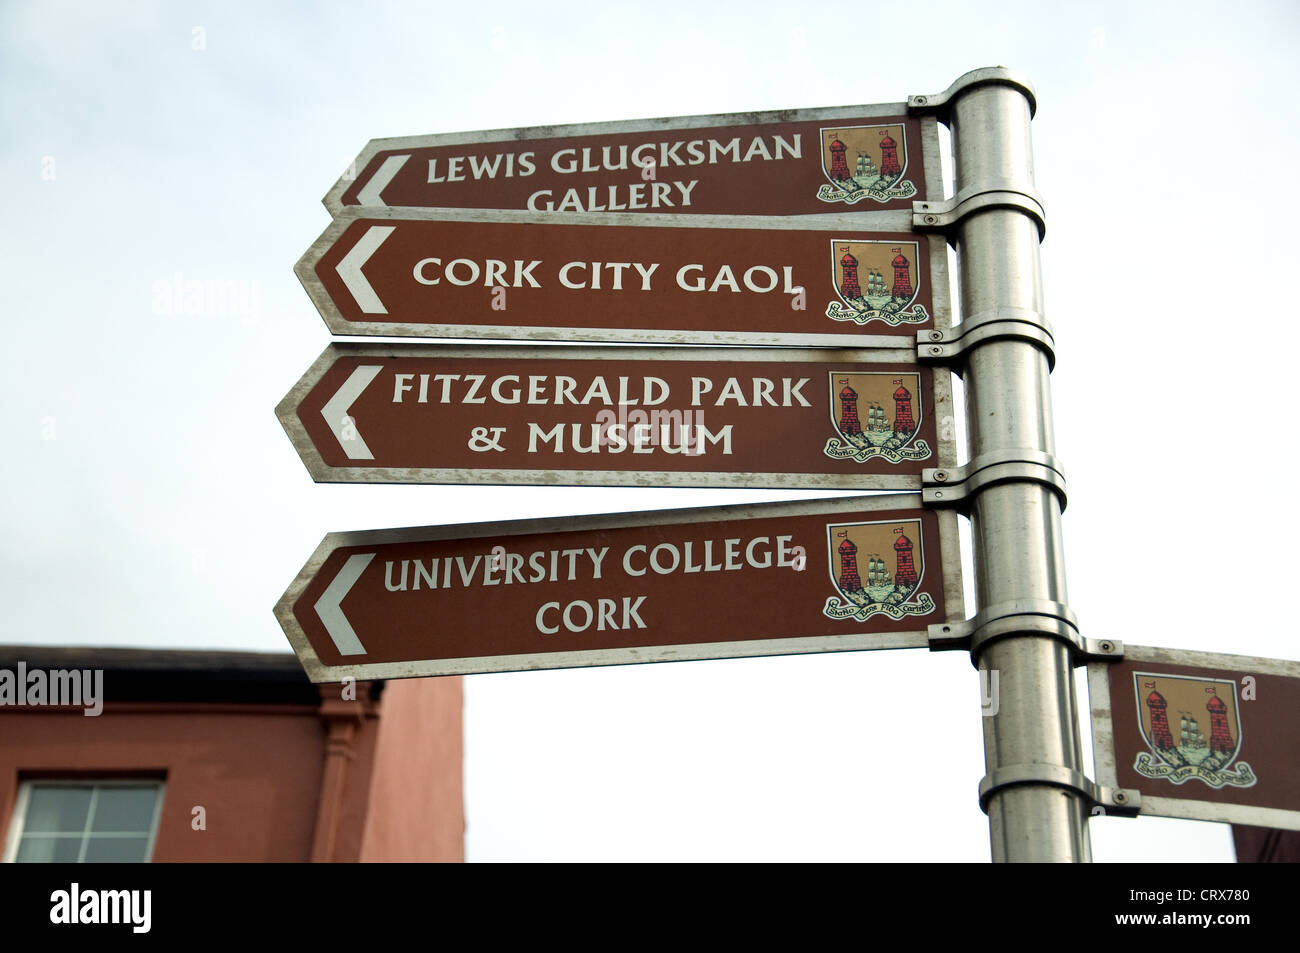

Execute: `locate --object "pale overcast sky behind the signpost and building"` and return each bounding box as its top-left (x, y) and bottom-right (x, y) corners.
top-left (0, 0), bottom-right (1300, 861)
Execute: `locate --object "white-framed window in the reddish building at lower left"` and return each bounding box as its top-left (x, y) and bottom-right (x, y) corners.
top-left (4, 780), bottom-right (163, 863)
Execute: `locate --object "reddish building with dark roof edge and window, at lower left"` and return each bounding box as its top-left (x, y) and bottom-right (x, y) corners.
top-left (0, 645), bottom-right (464, 861)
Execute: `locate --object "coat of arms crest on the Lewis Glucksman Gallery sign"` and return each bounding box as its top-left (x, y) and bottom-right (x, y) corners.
top-left (816, 122), bottom-right (917, 205)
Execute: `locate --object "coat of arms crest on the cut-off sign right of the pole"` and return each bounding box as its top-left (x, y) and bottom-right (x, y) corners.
top-left (1134, 672), bottom-right (1257, 789)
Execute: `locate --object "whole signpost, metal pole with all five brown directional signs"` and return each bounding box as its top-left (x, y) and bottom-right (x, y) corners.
top-left (276, 68), bottom-right (1268, 862)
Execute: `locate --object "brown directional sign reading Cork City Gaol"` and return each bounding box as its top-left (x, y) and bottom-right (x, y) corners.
top-left (296, 208), bottom-right (949, 347)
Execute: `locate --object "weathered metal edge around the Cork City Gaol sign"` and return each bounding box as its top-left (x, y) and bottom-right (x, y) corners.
top-left (294, 205), bottom-right (952, 350)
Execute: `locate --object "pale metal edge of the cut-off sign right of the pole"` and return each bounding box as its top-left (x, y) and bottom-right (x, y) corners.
top-left (1088, 642), bottom-right (1300, 831)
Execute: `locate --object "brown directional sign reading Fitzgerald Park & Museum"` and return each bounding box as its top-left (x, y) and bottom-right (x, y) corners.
top-left (276, 345), bottom-right (956, 489)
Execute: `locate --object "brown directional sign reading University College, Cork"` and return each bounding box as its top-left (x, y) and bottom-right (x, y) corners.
top-left (276, 494), bottom-right (963, 681)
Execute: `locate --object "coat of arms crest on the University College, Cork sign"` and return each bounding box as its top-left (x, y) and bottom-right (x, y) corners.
top-left (822, 520), bottom-right (935, 621)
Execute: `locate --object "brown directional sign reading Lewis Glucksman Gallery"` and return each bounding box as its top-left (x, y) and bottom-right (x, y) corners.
top-left (325, 103), bottom-right (943, 216)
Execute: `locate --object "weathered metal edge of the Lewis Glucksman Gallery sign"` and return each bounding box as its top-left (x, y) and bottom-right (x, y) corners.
top-left (321, 103), bottom-right (944, 217)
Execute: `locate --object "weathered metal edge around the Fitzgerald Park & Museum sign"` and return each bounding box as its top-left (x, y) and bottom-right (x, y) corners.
top-left (276, 342), bottom-right (957, 490)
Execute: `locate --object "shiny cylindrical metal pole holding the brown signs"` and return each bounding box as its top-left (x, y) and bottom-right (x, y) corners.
top-left (911, 69), bottom-right (1092, 862)
